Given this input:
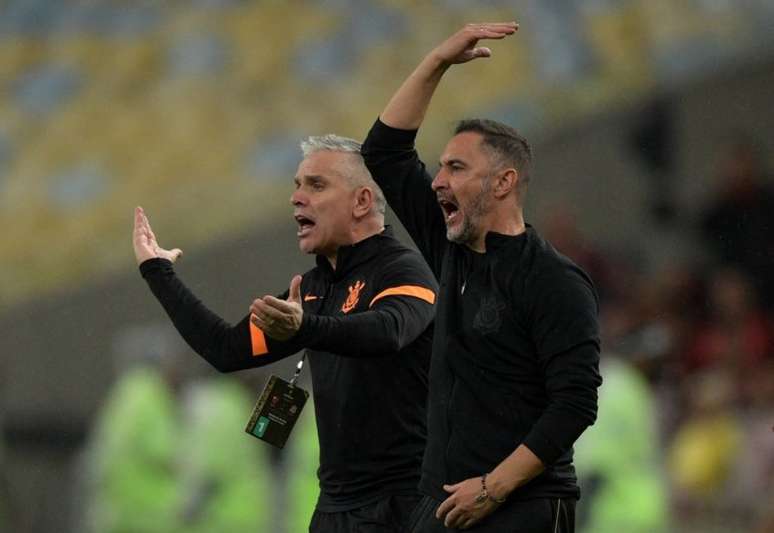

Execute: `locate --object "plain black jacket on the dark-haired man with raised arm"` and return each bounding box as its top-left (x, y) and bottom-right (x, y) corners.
top-left (362, 120), bottom-right (601, 501)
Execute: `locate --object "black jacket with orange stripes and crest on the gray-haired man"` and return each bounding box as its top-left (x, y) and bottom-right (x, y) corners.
top-left (140, 227), bottom-right (437, 512)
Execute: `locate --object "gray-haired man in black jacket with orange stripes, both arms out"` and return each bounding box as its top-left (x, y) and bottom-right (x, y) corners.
top-left (134, 135), bottom-right (438, 533)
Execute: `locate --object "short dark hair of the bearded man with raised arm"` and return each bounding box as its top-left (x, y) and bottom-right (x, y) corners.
top-left (454, 118), bottom-right (532, 190)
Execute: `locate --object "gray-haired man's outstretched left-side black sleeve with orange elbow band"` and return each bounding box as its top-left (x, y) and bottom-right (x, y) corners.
top-left (140, 258), bottom-right (302, 372)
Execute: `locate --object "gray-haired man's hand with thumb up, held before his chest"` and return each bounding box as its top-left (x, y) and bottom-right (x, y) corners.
top-left (250, 276), bottom-right (304, 341)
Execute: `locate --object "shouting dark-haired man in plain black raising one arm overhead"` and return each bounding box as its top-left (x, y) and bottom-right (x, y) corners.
top-left (363, 23), bottom-right (601, 533)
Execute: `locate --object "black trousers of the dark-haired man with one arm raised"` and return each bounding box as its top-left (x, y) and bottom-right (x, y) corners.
top-left (408, 496), bottom-right (575, 533)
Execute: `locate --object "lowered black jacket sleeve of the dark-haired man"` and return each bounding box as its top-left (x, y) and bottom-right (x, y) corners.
top-left (524, 271), bottom-right (602, 464)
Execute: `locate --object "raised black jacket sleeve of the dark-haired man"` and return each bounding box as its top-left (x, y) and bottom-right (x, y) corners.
top-left (362, 119), bottom-right (448, 277)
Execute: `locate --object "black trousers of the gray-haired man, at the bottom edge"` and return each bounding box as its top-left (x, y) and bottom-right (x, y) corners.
top-left (309, 494), bottom-right (422, 533)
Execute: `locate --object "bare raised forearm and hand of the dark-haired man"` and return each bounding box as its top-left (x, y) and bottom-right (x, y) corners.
top-left (380, 22), bottom-right (519, 130)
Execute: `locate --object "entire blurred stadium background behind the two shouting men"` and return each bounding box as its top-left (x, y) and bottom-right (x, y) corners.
top-left (0, 0), bottom-right (774, 533)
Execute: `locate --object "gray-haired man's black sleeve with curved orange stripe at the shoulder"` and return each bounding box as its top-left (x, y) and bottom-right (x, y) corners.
top-left (293, 250), bottom-right (438, 357)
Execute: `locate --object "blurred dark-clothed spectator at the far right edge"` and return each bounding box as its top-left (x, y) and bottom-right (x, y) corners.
top-left (701, 139), bottom-right (774, 309)
